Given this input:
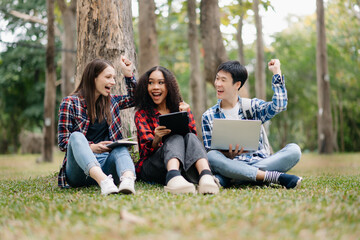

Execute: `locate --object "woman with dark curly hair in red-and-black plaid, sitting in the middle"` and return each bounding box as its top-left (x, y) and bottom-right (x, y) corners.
top-left (135, 66), bottom-right (219, 194)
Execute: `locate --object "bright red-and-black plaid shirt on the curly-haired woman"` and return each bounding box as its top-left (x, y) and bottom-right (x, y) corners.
top-left (135, 109), bottom-right (196, 174)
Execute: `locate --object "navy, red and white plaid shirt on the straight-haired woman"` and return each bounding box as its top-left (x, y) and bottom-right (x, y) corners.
top-left (58, 77), bottom-right (136, 187)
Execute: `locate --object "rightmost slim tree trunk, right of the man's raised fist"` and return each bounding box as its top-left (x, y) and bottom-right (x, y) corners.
top-left (316, 0), bottom-right (334, 154)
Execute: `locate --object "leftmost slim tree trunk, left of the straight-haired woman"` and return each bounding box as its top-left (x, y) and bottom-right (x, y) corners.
top-left (42, 0), bottom-right (56, 162)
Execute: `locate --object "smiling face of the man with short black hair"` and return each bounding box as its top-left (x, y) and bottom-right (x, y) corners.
top-left (214, 70), bottom-right (241, 107)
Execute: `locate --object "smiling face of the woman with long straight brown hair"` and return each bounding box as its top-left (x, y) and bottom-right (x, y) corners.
top-left (95, 66), bottom-right (115, 99)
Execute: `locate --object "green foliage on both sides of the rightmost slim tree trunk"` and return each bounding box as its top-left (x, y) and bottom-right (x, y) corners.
top-left (267, 1), bottom-right (360, 151)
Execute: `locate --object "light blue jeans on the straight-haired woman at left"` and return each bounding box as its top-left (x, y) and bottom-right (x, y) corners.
top-left (66, 132), bottom-right (135, 187)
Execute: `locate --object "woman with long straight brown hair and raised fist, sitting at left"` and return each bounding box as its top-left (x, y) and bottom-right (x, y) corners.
top-left (58, 57), bottom-right (136, 195)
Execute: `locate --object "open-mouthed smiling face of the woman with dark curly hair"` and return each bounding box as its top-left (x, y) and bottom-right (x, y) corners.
top-left (148, 70), bottom-right (168, 106)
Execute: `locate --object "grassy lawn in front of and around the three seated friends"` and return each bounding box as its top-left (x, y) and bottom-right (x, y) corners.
top-left (0, 153), bottom-right (360, 239)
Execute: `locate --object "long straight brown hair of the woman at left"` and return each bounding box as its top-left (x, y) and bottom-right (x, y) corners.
top-left (73, 59), bottom-right (114, 125)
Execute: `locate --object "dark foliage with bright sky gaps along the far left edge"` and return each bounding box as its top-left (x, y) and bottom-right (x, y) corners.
top-left (0, 1), bottom-right (59, 153)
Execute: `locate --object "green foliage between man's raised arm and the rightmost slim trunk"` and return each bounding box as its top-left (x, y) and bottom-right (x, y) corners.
top-left (266, 16), bottom-right (317, 150)
